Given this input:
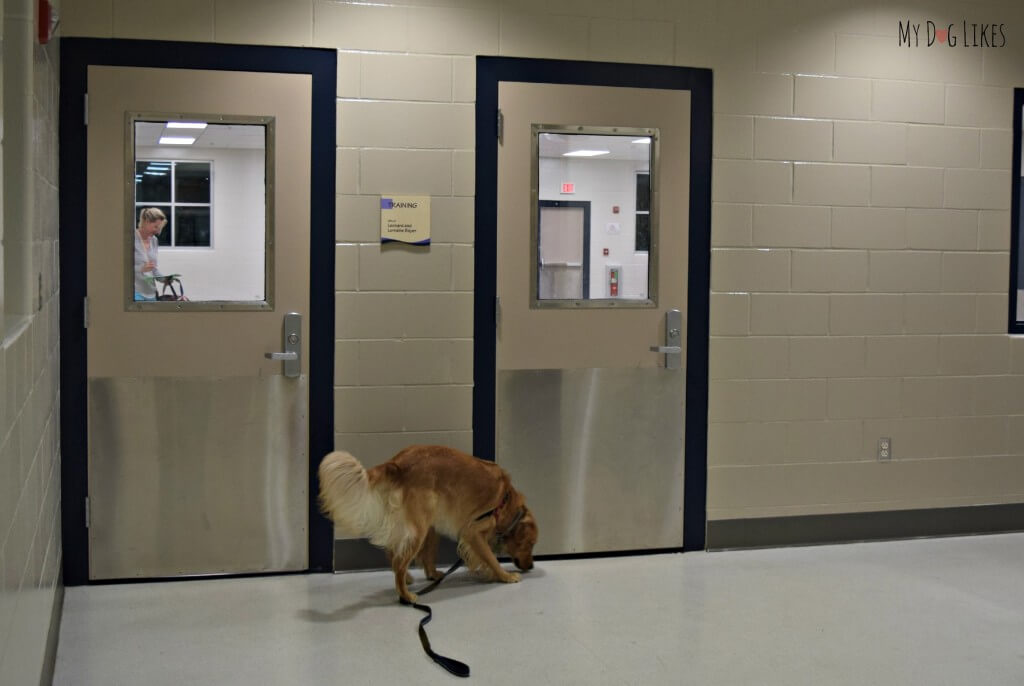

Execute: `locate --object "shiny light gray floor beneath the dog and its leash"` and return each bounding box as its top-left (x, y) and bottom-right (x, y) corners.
top-left (54, 533), bottom-right (1024, 686)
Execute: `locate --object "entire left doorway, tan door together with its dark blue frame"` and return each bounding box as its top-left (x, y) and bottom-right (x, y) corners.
top-left (60, 39), bottom-right (337, 585)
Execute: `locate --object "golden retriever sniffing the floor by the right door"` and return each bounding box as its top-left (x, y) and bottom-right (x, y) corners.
top-left (319, 445), bottom-right (538, 603)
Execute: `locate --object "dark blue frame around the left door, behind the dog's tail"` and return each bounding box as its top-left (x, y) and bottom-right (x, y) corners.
top-left (59, 38), bottom-right (338, 586)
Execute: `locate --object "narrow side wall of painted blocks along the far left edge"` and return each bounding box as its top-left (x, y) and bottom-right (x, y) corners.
top-left (0, 0), bottom-right (61, 686)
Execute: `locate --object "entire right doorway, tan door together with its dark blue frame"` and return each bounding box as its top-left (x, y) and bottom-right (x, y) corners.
top-left (473, 57), bottom-right (712, 555)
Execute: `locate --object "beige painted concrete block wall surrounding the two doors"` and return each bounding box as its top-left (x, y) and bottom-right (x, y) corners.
top-left (62, 0), bottom-right (1024, 519)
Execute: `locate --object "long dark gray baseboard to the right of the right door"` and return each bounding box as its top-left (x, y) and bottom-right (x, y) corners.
top-left (708, 503), bottom-right (1024, 550)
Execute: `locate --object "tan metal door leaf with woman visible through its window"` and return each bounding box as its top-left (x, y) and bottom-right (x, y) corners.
top-left (85, 67), bottom-right (311, 580)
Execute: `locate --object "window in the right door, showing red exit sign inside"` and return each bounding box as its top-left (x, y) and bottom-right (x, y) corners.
top-left (530, 124), bottom-right (657, 307)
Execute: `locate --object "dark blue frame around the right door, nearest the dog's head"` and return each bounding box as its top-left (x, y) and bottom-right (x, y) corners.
top-left (473, 56), bottom-right (712, 550)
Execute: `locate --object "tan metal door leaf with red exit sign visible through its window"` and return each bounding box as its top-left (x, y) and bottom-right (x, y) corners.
top-left (496, 82), bottom-right (690, 554)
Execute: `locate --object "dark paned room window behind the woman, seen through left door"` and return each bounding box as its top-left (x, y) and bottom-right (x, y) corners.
top-left (135, 160), bottom-right (213, 248)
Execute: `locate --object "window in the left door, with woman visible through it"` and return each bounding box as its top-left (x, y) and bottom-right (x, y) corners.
top-left (126, 114), bottom-right (273, 310)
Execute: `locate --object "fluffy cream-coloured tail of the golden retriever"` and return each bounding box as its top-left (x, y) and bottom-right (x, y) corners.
top-left (319, 451), bottom-right (394, 546)
